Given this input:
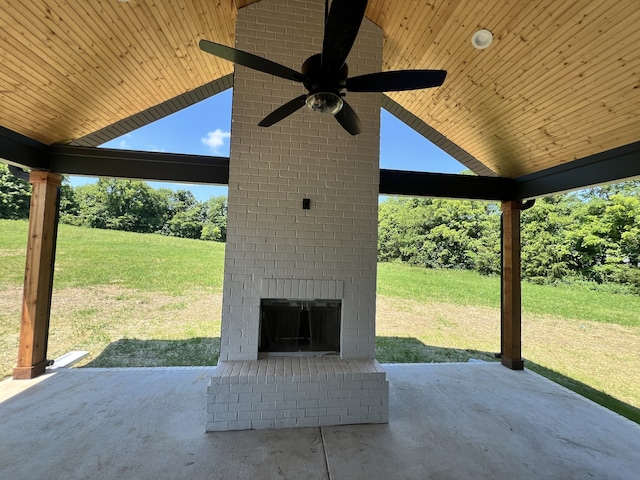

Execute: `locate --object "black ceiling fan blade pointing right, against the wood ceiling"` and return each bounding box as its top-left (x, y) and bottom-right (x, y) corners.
top-left (346, 70), bottom-right (447, 92)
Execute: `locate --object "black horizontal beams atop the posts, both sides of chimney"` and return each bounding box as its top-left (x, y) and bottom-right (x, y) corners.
top-left (0, 126), bottom-right (640, 200)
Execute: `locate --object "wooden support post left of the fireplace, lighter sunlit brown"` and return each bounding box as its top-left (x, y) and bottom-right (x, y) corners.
top-left (13, 171), bottom-right (62, 380)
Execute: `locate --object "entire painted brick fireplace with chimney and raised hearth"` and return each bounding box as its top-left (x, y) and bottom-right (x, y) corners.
top-left (207, 0), bottom-right (388, 431)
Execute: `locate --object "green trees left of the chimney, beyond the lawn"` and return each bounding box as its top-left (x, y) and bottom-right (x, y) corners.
top-left (0, 164), bottom-right (227, 242)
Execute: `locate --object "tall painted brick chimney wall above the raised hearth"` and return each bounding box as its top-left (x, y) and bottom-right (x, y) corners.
top-left (220, 0), bottom-right (383, 362)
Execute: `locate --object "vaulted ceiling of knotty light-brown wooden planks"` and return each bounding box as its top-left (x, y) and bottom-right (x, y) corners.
top-left (0, 0), bottom-right (640, 178)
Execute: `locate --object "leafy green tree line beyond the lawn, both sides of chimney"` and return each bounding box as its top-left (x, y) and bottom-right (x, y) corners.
top-left (0, 164), bottom-right (640, 293)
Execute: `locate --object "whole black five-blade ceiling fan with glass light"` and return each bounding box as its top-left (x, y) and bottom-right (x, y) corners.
top-left (199, 0), bottom-right (447, 135)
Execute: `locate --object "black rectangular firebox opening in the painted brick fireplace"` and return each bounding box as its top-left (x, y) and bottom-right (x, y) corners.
top-left (258, 299), bottom-right (341, 355)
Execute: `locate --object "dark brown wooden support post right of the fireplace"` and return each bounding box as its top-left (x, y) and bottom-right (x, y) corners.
top-left (500, 201), bottom-right (524, 370)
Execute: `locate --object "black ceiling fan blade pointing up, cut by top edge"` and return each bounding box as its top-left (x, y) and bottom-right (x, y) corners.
top-left (322, 0), bottom-right (367, 81)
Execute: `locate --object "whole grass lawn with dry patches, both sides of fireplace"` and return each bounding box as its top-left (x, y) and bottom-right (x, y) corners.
top-left (0, 220), bottom-right (640, 422)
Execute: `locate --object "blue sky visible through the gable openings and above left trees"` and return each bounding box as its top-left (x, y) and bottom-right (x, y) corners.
top-left (70, 89), bottom-right (465, 201)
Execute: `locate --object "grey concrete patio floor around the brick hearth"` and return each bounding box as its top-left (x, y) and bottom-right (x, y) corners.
top-left (0, 363), bottom-right (640, 480)
